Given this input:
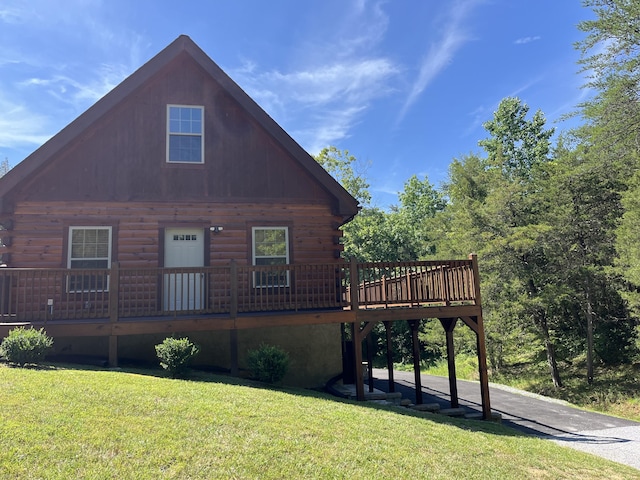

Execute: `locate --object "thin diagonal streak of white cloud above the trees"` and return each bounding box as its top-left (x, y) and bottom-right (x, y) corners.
top-left (397, 0), bottom-right (479, 123)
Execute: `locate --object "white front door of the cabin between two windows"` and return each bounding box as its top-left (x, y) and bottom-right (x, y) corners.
top-left (164, 228), bottom-right (205, 311)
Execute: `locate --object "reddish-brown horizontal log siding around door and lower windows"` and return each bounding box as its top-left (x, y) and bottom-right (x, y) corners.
top-left (4, 202), bottom-right (342, 268)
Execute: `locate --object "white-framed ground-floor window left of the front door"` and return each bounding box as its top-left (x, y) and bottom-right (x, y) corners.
top-left (67, 227), bottom-right (111, 292)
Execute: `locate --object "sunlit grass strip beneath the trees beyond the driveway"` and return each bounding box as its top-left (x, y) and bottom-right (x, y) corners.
top-left (423, 355), bottom-right (640, 421)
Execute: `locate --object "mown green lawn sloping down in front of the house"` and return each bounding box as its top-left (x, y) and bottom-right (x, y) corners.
top-left (0, 364), bottom-right (640, 479)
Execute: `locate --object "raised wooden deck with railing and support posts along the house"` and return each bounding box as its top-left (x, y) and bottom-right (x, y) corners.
top-left (0, 255), bottom-right (490, 418)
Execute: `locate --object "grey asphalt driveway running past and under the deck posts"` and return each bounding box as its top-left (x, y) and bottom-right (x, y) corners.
top-left (365, 369), bottom-right (640, 470)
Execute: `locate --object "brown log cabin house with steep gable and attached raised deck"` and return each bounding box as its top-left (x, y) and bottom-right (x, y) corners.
top-left (0, 35), bottom-right (489, 414)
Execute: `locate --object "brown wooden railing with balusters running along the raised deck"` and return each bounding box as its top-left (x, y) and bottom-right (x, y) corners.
top-left (0, 255), bottom-right (477, 322)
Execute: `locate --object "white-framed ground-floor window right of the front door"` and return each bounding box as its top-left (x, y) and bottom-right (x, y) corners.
top-left (252, 227), bottom-right (289, 287)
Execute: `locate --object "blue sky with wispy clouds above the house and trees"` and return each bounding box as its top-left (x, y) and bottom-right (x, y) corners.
top-left (0, 0), bottom-right (593, 207)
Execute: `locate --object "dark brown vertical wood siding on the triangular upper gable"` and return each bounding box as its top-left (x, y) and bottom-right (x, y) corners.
top-left (4, 54), bottom-right (338, 213)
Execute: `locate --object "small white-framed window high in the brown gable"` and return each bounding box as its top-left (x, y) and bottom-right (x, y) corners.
top-left (167, 105), bottom-right (204, 163)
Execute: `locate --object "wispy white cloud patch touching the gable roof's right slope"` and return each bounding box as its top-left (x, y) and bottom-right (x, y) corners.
top-left (229, 0), bottom-right (401, 153)
